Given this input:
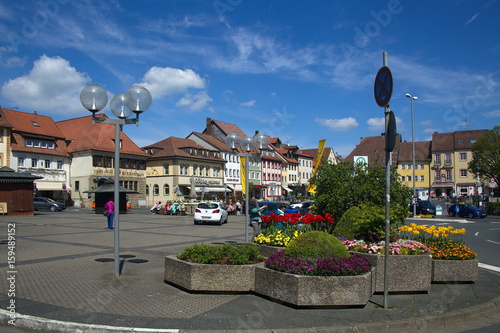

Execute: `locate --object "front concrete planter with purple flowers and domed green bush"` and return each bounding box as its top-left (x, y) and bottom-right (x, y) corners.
top-left (255, 231), bottom-right (373, 307)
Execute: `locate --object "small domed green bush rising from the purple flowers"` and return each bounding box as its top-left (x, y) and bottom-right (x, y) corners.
top-left (285, 231), bottom-right (350, 258)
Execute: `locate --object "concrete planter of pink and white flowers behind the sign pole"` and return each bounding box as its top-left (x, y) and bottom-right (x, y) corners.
top-left (343, 240), bottom-right (432, 292)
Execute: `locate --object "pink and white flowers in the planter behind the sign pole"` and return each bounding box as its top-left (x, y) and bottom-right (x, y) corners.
top-left (342, 239), bottom-right (431, 255)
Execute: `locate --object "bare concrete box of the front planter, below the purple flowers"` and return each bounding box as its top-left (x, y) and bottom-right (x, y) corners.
top-left (255, 266), bottom-right (373, 307)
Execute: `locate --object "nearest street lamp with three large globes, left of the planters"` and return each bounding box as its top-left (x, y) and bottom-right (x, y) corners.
top-left (80, 84), bottom-right (152, 277)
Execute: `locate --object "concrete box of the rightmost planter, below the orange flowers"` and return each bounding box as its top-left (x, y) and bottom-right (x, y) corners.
top-left (432, 259), bottom-right (478, 282)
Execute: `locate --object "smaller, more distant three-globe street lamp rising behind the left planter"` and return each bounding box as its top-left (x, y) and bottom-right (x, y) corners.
top-left (226, 133), bottom-right (269, 243)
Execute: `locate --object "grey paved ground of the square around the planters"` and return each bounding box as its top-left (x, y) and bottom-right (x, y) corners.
top-left (0, 208), bottom-right (500, 333)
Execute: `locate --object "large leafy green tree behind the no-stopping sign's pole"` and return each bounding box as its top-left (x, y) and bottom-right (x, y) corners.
top-left (311, 162), bottom-right (412, 223)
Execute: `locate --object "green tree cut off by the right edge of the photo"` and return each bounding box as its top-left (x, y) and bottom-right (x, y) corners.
top-left (469, 126), bottom-right (500, 184)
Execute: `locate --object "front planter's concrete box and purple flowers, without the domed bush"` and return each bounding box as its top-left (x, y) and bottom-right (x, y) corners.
top-left (255, 252), bottom-right (373, 306)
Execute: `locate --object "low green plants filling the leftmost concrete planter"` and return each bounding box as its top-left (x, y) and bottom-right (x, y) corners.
top-left (177, 244), bottom-right (264, 265)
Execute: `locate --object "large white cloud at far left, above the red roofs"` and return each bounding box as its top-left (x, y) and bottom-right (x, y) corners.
top-left (2, 55), bottom-right (90, 116)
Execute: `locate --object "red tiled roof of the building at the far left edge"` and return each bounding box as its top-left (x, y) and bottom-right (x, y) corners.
top-left (3, 109), bottom-right (64, 139)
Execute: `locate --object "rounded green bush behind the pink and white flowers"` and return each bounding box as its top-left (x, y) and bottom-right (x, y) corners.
top-left (333, 204), bottom-right (396, 242)
